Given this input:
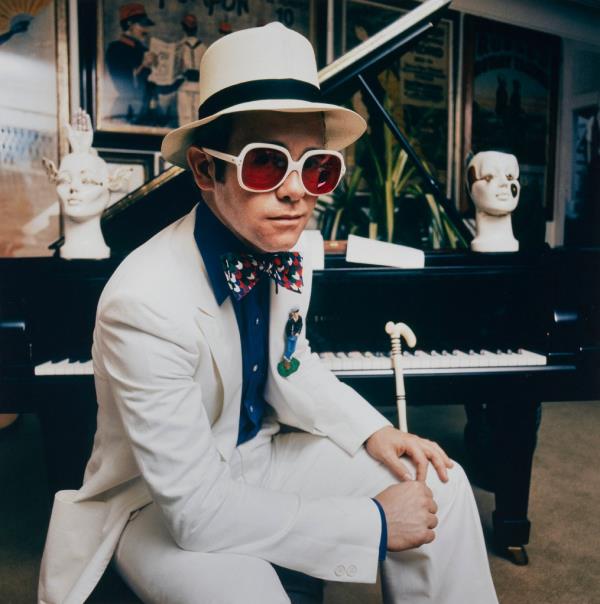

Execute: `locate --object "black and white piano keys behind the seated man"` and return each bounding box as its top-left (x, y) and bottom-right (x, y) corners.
top-left (35, 348), bottom-right (546, 375)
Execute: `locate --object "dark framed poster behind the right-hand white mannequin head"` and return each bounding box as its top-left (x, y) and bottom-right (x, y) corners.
top-left (461, 17), bottom-right (560, 220)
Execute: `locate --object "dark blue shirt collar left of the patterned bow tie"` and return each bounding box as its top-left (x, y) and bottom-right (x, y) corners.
top-left (194, 201), bottom-right (248, 306)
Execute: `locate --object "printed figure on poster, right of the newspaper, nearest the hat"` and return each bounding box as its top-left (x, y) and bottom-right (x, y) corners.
top-left (177, 14), bottom-right (206, 125)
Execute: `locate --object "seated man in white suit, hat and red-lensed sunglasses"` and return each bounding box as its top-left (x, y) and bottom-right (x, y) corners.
top-left (40, 24), bottom-right (497, 604)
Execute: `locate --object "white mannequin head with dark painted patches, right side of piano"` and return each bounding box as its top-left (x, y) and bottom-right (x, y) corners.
top-left (467, 151), bottom-right (521, 252)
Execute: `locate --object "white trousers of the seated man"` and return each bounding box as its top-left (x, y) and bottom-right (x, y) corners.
top-left (115, 426), bottom-right (498, 604)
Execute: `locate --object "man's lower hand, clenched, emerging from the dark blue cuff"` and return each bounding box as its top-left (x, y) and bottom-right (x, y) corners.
top-left (375, 480), bottom-right (438, 552)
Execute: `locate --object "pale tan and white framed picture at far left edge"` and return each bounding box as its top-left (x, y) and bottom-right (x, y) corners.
top-left (0, 0), bottom-right (69, 256)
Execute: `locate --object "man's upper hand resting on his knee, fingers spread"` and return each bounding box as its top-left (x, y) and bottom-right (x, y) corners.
top-left (365, 426), bottom-right (453, 482)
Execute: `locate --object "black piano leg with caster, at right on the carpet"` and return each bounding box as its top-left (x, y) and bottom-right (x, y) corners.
top-left (487, 400), bottom-right (541, 565)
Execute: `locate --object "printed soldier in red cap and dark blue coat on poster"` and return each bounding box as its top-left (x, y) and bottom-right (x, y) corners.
top-left (106, 2), bottom-right (156, 123)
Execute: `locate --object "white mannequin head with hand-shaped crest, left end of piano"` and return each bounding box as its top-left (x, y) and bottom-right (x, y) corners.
top-left (43, 109), bottom-right (131, 259)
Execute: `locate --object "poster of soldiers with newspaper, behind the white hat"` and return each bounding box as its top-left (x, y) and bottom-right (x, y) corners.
top-left (94, 0), bottom-right (311, 135)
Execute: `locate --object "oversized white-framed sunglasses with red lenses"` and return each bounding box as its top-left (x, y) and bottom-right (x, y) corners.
top-left (202, 143), bottom-right (346, 195)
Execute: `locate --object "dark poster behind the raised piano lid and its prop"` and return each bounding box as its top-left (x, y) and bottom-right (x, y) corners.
top-left (341, 0), bottom-right (454, 195)
